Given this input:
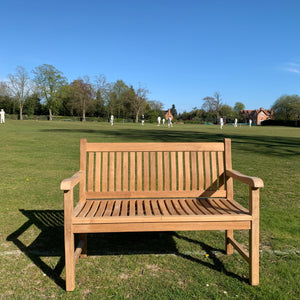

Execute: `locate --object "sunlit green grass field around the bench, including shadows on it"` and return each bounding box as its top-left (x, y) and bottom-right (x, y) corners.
top-left (0, 120), bottom-right (300, 299)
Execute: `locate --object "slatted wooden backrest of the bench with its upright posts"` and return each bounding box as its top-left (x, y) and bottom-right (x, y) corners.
top-left (80, 139), bottom-right (231, 199)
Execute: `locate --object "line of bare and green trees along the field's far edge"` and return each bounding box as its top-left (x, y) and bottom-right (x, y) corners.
top-left (0, 64), bottom-right (300, 123)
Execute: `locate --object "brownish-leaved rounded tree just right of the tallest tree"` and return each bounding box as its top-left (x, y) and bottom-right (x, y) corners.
top-left (70, 76), bottom-right (94, 122)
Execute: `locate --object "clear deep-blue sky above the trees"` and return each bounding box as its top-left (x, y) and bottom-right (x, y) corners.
top-left (0, 0), bottom-right (300, 111)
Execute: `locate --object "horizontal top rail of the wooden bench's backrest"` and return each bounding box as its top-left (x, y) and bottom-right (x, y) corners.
top-left (86, 143), bottom-right (224, 152)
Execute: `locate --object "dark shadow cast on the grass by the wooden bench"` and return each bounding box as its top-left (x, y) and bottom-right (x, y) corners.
top-left (7, 209), bottom-right (246, 289)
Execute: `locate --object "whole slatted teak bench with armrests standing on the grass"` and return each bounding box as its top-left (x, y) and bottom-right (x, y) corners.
top-left (61, 139), bottom-right (263, 291)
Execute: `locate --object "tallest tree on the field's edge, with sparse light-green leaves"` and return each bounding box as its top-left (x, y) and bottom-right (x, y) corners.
top-left (32, 64), bottom-right (66, 121)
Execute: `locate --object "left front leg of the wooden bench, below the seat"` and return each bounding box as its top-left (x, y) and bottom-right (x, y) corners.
top-left (65, 232), bottom-right (75, 291)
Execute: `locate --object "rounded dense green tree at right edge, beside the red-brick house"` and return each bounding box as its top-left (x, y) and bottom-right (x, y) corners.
top-left (272, 95), bottom-right (300, 120)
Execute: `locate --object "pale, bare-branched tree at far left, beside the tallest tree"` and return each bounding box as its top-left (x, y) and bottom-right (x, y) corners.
top-left (8, 66), bottom-right (32, 120)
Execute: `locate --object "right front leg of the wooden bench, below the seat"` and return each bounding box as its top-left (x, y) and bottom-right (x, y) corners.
top-left (249, 221), bottom-right (259, 285)
